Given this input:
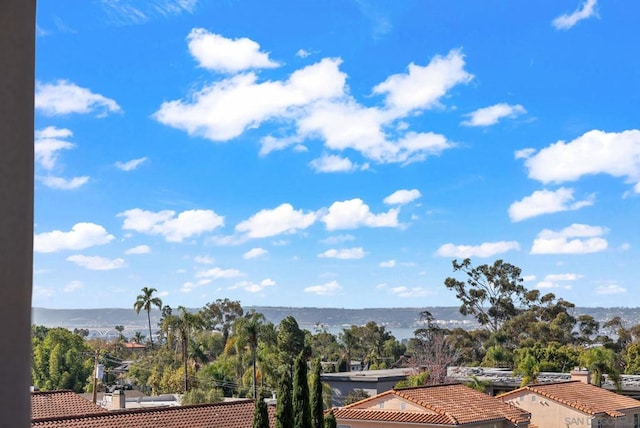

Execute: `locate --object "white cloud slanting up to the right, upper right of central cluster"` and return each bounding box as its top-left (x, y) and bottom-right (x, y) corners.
top-left (373, 49), bottom-right (473, 115)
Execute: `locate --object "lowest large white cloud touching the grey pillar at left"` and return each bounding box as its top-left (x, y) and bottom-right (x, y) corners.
top-left (33, 223), bottom-right (114, 253)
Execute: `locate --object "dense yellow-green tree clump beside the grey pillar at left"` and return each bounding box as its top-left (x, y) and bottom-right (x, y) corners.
top-left (31, 327), bottom-right (94, 392)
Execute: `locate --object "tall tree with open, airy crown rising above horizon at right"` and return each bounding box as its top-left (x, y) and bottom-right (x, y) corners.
top-left (444, 259), bottom-right (539, 332)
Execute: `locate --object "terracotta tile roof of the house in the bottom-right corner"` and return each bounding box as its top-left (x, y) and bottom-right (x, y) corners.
top-left (499, 380), bottom-right (640, 417)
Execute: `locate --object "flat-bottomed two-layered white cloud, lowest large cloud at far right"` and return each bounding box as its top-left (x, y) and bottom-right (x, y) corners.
top-left (531, 224), bottom-right (608, 254)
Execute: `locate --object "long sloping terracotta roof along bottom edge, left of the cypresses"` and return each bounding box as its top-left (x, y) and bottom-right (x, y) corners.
top-left (31, 400), bottom-right (275, 428)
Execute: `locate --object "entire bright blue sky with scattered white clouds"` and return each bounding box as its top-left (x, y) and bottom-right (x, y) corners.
top-left (33, 0), bottom-right (640, 308)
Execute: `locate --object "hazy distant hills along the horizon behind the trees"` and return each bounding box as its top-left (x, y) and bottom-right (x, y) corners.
top-left (31, 306), bottom-right (640, 339)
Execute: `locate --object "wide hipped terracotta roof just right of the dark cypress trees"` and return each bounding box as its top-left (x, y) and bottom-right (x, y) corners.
top-left (334, 384), bottom-right (531, 425)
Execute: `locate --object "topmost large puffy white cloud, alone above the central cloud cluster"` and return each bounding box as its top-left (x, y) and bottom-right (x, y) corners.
top-left (187, 28), bottom-right (279, 73)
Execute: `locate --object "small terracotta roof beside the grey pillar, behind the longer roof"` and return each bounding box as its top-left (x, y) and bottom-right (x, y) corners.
top-left (31, 390), bottom-right (108, 419)
